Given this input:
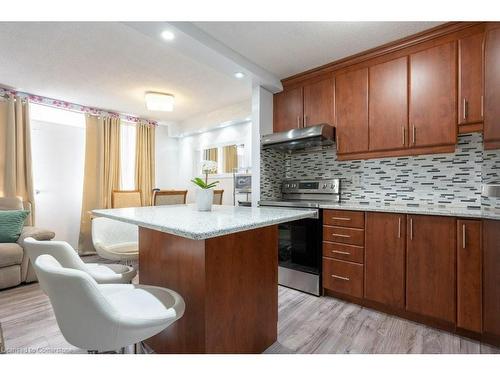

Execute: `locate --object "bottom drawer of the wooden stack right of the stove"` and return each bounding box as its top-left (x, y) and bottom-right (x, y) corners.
top-left (323, 258), bottom-right (363, 298)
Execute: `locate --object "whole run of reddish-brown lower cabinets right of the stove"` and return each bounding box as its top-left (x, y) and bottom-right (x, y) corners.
top-left (323, 210), bottom-right (500, 346)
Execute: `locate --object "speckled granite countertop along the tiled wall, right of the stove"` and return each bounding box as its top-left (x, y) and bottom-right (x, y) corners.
top-left (320, 203), bottom-right (500, 220)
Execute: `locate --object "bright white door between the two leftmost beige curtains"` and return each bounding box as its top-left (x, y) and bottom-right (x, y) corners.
top-left (31, 105), bottom-right (85, 249)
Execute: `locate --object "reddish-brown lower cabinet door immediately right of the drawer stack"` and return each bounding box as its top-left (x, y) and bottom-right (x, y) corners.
top-left (365, 212), bottom-right (406, 309)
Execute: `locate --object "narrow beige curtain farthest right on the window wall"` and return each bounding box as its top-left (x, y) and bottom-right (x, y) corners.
top-left (135, 123), bottom-right (155, 206)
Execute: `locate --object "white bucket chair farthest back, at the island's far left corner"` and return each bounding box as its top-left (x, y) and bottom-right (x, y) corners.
top-left (92, 217), bottom-right (139, 262)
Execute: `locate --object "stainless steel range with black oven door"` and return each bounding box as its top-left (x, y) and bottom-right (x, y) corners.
top-left (259, 179), bottom-right (340, 296)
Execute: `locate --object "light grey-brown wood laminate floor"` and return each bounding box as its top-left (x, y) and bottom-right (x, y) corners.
top-left (0, 284), bottom-right (500, 353)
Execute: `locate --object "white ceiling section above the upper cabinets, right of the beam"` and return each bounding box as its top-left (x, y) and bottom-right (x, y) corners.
top-left (195, 22), bottom-right (443, 79)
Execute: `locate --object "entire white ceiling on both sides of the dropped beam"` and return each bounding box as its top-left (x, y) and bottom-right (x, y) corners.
top-left (0, 22), bottom-right (446, 129)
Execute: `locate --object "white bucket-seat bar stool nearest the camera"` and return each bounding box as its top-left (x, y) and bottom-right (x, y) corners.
top-left (34, 254), bottom-right (185, 353)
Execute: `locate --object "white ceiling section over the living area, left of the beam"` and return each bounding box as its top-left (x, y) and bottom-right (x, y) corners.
top-left (0, 22), bottom-right (251, 123)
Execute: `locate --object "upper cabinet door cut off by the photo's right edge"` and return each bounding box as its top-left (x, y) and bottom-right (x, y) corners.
top-left (484, 28), bottom-right (500, 148)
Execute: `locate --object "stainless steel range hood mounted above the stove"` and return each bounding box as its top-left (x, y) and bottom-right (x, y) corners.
top-left (260, 124), bottom-right (335, 152)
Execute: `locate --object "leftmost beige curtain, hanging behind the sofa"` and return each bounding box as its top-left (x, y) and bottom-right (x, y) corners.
top-left (0, 96), bottom-right (35, 225)
